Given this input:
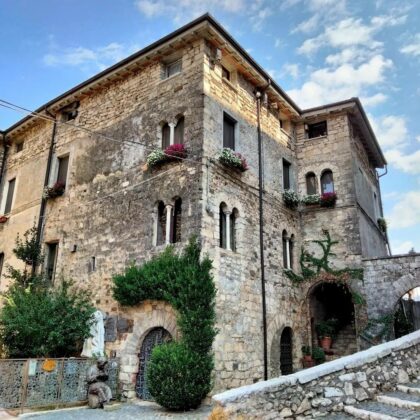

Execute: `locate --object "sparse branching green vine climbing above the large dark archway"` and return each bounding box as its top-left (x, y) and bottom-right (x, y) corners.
top-left (284, 229), bottom-right (365, 304)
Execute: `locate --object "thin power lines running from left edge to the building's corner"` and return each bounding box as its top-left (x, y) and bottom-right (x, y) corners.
top-left (0, 99), bottom-right (201, 164)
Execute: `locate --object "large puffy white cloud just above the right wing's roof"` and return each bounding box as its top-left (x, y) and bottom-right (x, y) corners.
top-left (288, 54), bottom-right (392, 108)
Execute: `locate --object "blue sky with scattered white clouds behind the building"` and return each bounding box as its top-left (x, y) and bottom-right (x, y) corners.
top-left (0, 0), bottom-right (420, 254)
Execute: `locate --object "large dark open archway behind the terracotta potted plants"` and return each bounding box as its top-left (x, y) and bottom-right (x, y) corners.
top-left (309, 282), bottom-right (358, 356)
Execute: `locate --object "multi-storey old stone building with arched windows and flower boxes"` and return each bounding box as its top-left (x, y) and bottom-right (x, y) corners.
top-left (0, 15), bottom-right (420, 397)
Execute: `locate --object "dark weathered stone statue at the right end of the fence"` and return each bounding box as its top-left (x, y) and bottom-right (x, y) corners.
top-left (87, 357), bottom-right (112, 408)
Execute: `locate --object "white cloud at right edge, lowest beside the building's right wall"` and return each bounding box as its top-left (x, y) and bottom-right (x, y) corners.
top-left (387, 191), bottom-right (420, 229)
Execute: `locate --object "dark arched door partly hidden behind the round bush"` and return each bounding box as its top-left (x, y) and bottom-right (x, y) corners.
top-left (136, 327), bottom-right (172, 400)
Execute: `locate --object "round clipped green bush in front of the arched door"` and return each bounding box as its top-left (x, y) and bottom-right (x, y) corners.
top-left (147, 342), bottom-right (213, 411)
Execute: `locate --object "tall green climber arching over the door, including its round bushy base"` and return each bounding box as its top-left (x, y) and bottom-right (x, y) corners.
top-left (113, 239), bottom-right (216, 410)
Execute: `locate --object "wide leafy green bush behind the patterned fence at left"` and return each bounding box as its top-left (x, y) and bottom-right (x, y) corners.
top-left (0, 282), bottom-right (95, 358)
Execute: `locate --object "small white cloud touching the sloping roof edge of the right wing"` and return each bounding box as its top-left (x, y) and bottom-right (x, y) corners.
top-left (369, 115), bottom-right (408, 149)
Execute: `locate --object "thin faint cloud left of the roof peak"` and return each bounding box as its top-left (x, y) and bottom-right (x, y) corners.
top-left (43, 42), bottom-right (138, 70)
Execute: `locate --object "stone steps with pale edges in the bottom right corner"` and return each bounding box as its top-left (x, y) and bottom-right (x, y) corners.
top-left (328, 377), bottom-right (420, 420)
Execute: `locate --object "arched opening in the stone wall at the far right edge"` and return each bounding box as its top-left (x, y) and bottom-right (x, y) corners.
top-left (394, 286), bottom-right (420, 338)
